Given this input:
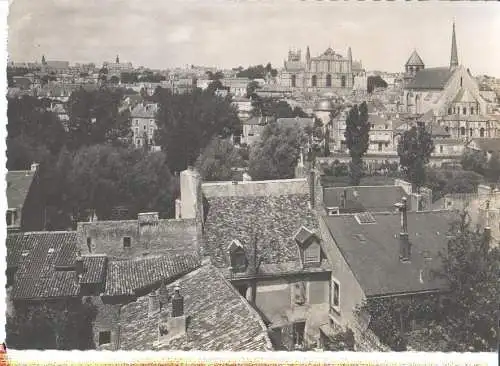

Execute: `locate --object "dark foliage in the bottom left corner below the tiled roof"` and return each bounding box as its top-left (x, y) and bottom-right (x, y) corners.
top-left (6, 303), bottom-right (97, 350)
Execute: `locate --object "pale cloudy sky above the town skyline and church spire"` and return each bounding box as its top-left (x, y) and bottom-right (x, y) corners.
top-left (8, 0), bottom-right (500, 77)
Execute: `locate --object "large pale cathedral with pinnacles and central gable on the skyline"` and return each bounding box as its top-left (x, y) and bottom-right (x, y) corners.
top-left (280, 47), bottom-right (366, 92)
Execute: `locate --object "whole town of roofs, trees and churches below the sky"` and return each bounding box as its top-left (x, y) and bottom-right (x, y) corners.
top-left (6, 17), bottom-right (500, 352)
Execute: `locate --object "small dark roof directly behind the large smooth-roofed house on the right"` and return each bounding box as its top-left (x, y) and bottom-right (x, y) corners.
top-left (323, 186), bottom-right (410, 212)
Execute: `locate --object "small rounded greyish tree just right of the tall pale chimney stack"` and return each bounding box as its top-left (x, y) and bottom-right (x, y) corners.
top-left (196, 137), bottom-right (243, 181)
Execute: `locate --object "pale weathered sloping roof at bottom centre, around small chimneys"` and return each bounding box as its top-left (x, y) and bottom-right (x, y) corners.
top-left (120, 265), bottom-right (272, 351)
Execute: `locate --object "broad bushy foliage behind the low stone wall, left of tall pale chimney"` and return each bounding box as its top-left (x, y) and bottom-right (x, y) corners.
top-left (64, 145), bottom-right (173, 219)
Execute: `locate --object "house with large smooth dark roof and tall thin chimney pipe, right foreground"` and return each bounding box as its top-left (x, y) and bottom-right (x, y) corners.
top-left (320, 200), bottom-right (454, 338)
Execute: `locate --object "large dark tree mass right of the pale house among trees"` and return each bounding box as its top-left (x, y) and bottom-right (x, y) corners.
top-left (155, 89), bottom-right (241, 171)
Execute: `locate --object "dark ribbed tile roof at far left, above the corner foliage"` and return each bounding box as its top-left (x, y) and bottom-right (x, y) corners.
top-left (7, 231), bottom-right (79, 299)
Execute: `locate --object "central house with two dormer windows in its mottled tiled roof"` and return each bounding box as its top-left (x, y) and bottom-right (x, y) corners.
top-left (202, 179), bottom-right (331, 349)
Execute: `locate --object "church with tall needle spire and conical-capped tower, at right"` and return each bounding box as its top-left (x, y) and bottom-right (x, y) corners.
top-left (402, 23), bottom-right (500, 139)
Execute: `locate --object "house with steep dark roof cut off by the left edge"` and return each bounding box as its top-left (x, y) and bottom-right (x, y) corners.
top-left (6, 163), bottom-right (45, 231)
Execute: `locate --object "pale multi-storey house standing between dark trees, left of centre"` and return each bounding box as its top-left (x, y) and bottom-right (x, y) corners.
top-left (130, 102), bottom-right (158, 150)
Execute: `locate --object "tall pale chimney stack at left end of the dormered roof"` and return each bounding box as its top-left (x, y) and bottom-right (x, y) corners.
top-left (180, 165), bottom-right (203, 219)
